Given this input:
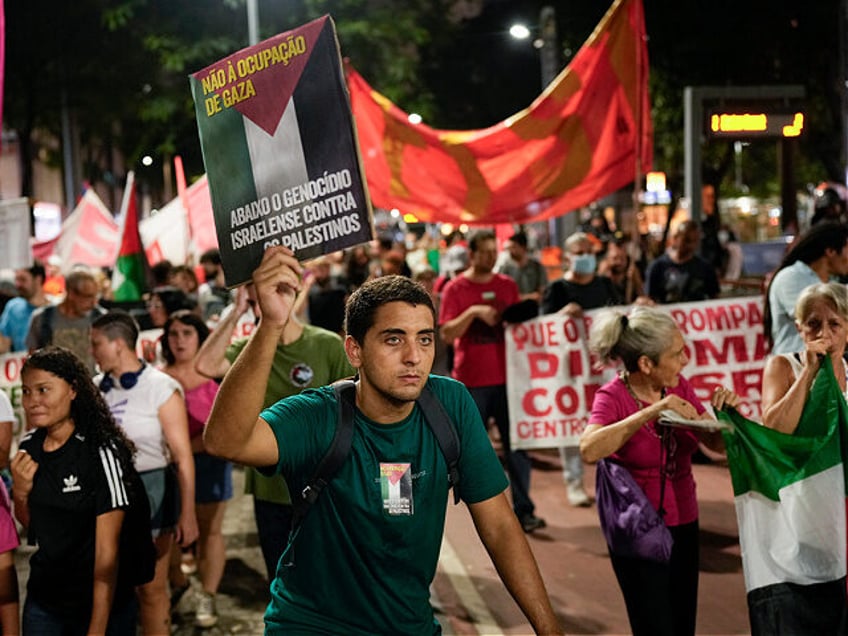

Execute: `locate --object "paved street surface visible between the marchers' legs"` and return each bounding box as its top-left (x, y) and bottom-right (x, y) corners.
top-left (9, 451), bottom-right (748, 636)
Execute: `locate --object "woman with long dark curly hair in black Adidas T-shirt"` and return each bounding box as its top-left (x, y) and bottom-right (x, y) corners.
top-left (11, 347), bottom-right (142, 634)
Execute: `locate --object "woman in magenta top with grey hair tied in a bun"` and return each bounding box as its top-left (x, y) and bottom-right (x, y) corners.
top-left (580, 307), bottom-right (739, 636)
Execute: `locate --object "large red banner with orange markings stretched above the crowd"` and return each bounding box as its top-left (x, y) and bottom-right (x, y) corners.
top-left (348, 0), bottom-right (653, 225)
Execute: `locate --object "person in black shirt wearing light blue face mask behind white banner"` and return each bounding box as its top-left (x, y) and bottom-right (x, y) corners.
top-left (542, 232), bottom-right (624, 507)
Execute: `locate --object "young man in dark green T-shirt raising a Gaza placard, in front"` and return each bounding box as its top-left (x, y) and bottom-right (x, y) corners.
top-left (204, 246), bottom-right (562, 634)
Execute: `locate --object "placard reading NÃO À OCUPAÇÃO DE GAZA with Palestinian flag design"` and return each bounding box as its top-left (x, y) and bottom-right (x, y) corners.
top-left (191, 16), bottom-right (372, 286)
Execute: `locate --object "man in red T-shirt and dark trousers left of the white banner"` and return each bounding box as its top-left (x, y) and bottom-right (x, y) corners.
top-left (439, 231), bottom-right (545, 532)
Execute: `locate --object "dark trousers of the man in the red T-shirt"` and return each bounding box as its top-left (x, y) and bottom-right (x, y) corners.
top-left (468, 384), bottom-right (536, 518)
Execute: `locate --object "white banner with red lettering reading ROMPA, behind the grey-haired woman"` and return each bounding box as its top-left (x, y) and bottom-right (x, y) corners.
top-left (506, 297), bottom-right (766, 448)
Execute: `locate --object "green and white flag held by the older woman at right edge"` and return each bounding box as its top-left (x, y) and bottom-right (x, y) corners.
top-left (718, 364), bottom-right (848, 592)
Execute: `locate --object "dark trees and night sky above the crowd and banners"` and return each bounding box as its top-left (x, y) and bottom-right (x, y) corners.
top-left (4, 0), bottom-right (844, 212)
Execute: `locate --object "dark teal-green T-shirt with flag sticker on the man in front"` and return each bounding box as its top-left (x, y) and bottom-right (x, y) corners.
top-left (261, 376), bottom-right (507, 635)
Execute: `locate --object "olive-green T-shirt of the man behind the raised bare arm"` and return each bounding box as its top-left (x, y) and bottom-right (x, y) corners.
top-left (227, 325), bottom-right (354, 504)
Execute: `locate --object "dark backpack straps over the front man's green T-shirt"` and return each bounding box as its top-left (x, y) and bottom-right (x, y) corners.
top-left (289, 380), bottom-right (460, 547)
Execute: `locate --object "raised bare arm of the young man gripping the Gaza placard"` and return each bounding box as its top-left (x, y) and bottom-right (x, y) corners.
top-left (203, 247), bottom-right (301, 466)
